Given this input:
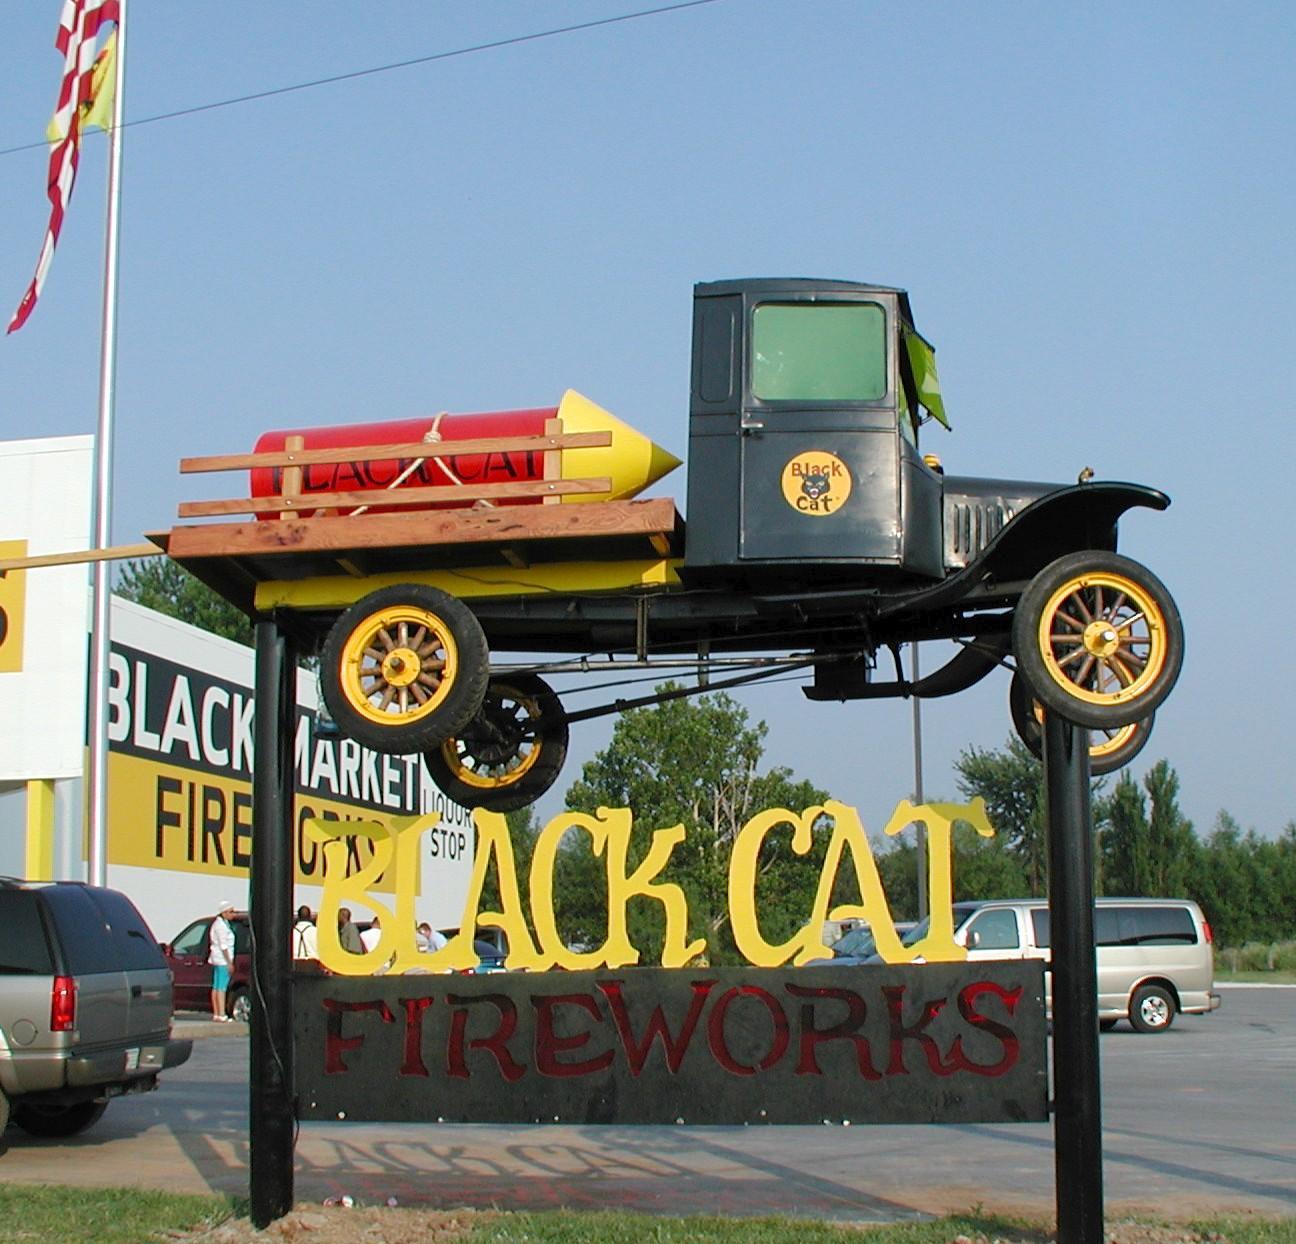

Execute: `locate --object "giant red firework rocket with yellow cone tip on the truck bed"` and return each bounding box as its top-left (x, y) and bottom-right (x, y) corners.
top-left (251, 389), bottom-right (679, 517)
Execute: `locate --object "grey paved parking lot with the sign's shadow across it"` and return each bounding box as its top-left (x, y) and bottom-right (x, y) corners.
top-left (0, 986), bottom-right (1296, 1221)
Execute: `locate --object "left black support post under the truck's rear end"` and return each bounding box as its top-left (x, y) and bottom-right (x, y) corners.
top-left (248, 621), bottom-right (297, 1228)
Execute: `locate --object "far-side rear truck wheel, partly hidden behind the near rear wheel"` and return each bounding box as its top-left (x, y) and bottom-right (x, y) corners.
top-left (422, 674), bottom-right (568, 812)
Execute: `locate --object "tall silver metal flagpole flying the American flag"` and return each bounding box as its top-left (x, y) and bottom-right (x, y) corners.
top-left (86, 0), bottom-right (126, 885)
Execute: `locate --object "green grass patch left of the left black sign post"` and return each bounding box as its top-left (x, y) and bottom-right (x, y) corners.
top-left (0, 1184), bottom-right (239, 1244)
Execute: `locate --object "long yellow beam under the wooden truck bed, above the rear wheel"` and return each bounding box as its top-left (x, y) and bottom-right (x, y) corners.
top-left (247, 557), bottom-right (683, 612)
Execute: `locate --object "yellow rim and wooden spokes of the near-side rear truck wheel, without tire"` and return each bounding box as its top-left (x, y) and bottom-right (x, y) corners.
top-left (340, 605), bottom-right (459, 726)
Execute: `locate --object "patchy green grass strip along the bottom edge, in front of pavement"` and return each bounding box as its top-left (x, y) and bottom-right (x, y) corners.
top-left (0, 1184), bottom-right (1296, 1244)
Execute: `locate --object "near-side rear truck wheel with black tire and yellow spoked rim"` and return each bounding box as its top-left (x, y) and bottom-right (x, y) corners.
top-left (320, 583), bottom-right (490, 755)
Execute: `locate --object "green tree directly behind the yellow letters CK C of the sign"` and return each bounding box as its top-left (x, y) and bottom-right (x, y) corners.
top-left (555, 683), bottom-right (827, 963)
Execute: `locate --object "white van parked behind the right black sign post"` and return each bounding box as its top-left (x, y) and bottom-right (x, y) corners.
top-left (905, 898), bottom-right (1220, 1033)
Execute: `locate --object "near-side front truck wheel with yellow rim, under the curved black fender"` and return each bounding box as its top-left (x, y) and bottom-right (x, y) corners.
top-left (1012, 549), bottom-right (1183, 730)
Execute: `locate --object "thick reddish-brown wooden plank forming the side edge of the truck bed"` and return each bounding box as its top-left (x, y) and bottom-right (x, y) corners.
top-left (167, 498), bottom-right (678, 562)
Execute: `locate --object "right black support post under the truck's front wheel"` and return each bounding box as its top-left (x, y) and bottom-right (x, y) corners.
top-left (1045, 713), bottom-right (1103, 1244)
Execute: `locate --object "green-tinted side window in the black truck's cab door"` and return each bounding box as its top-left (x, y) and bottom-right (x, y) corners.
top-left (752, 302), bottom-right (886, 402)
